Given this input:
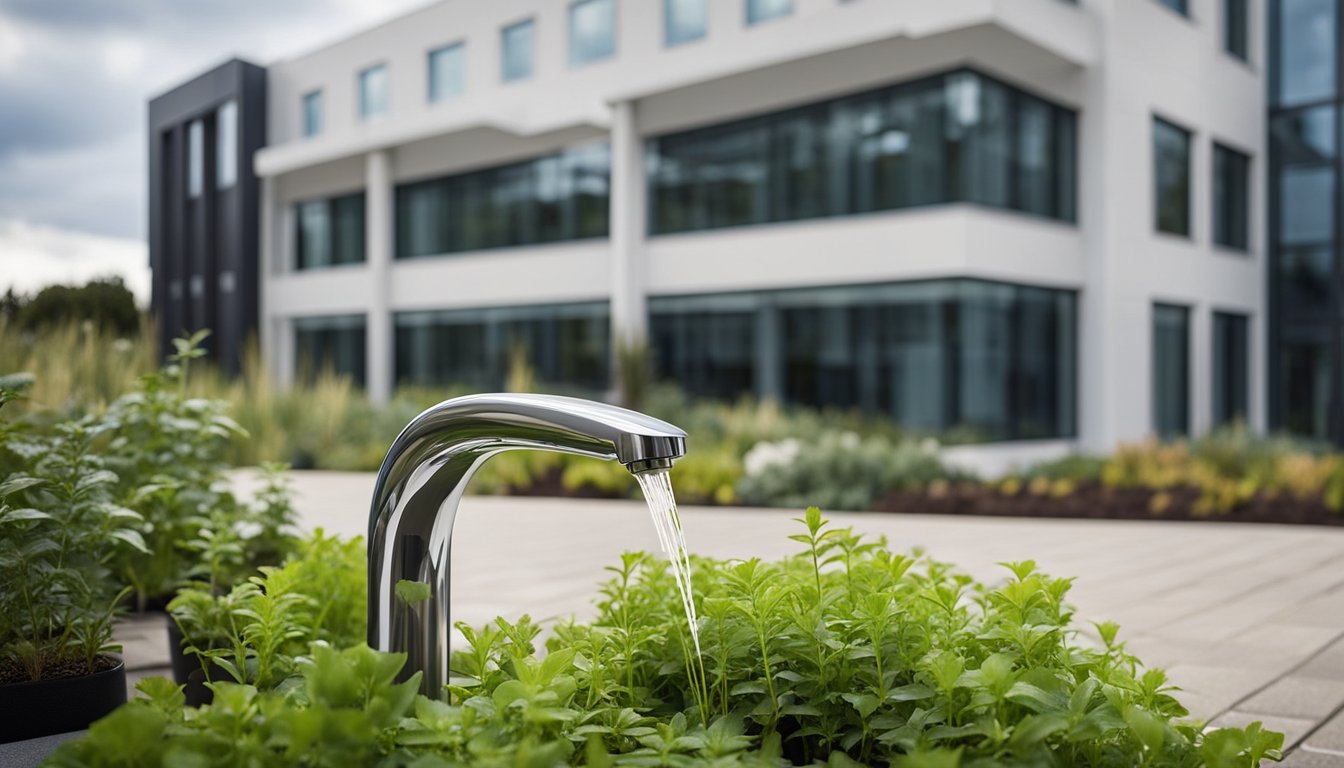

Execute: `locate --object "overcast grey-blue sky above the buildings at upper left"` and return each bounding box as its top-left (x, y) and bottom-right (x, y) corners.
top-left (0, 0), bottom-right (424, 303)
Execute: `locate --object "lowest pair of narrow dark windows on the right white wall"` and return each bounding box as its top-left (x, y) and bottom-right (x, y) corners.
top-left (1152, 304), bottom-right (1250, 437)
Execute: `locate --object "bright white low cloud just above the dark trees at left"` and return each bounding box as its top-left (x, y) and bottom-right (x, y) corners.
top-left (0, 219), bottom-right (149, 305)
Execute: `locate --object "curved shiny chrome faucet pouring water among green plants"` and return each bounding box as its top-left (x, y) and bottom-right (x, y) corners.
top-left (368, 394), bottom-right (685, 698)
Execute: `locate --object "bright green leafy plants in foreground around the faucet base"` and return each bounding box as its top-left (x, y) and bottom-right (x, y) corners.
top-left (52, 508), bottom-right (1282, 768)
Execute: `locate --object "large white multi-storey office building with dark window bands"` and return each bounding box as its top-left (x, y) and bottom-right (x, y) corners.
top-left (156, 0), bottom-right (1284, 451)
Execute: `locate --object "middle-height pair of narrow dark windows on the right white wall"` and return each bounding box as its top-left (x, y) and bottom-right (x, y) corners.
top-left (1153, 117), bottom-right (1251, 250)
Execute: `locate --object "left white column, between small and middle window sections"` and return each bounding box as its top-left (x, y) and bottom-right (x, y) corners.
top-left (364, 149), bottom-right (394, 404)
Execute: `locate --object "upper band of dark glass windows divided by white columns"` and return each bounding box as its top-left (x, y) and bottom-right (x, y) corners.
top-left (296, 71), bottom-right (1080, 269)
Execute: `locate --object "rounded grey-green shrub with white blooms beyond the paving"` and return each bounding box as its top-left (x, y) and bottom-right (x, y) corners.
top-left (737, 432), bottom-right (968, 510)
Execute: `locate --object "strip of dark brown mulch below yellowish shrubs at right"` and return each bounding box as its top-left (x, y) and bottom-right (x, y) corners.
top-left (874, 483), bottom-right (1344, 526)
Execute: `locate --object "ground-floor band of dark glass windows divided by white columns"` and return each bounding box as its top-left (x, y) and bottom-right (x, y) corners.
top-left (296, 280), bottom-right (1078, 440)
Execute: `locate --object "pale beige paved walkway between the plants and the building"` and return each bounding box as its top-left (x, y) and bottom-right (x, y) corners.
top-left (125, 472), bottom-right (1344, 768)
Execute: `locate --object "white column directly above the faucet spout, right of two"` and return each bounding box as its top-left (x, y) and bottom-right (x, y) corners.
top-left (610, 101), bottom-right (649, 358)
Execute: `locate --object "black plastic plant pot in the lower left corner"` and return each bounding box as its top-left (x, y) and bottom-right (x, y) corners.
top-left (0, 659), bottom-right (126, 744)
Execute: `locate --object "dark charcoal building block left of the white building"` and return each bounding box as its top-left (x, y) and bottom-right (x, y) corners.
top-left (149, 59), bottom-right (266, 370)
